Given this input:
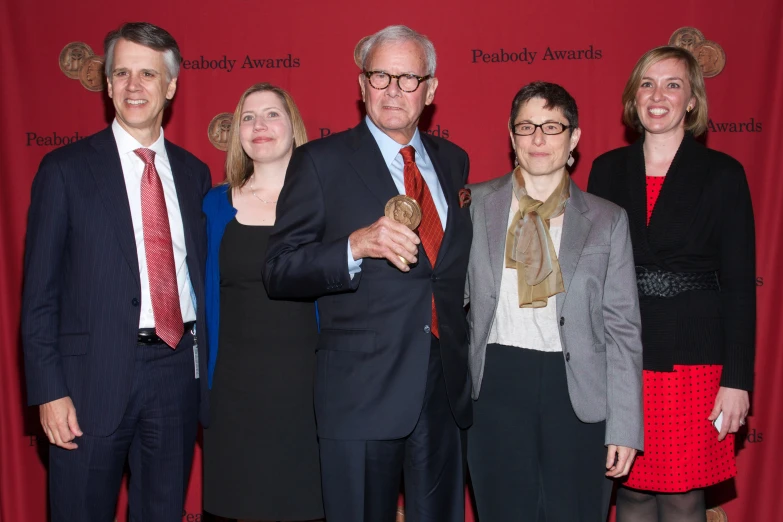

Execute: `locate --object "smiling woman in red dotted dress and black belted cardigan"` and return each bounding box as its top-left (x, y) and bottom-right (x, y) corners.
top-left (588, 47), bottom-right (756, 522)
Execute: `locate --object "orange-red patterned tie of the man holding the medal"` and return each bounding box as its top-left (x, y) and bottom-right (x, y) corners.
top-left (400, 145), bottom-right (443, 337)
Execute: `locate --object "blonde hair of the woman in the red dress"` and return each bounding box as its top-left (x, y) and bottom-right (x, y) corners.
top-left (623, 46), bottom-right (709, 136)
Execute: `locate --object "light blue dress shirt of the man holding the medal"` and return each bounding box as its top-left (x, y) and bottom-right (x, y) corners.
top-left (348, 116), bottom-right (449, 279)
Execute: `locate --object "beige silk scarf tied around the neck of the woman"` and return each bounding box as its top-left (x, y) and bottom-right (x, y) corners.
top-left (506, 167), bottom-right (571, 308)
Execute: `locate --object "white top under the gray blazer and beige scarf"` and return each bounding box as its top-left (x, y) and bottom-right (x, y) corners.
top-left (488, 202), bottom-right (563, 352)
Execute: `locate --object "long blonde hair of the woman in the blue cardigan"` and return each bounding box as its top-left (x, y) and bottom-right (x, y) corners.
top-left (225, 83), bottom-right (307, 189)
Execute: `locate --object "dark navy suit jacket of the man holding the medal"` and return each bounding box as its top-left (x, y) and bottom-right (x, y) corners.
top-left (264, 122), bottom-right (472, 440)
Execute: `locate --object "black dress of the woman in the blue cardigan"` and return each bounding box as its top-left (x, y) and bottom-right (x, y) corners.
top-left (204, 219), bottom-right (323, 521)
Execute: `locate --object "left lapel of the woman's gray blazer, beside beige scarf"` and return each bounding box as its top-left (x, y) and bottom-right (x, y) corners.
top-left (482, 174), bottom-right (514, 288)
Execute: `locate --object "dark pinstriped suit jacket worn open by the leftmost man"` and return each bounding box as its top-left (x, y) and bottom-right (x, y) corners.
top-left (22, 127), bottom-right (211, 436)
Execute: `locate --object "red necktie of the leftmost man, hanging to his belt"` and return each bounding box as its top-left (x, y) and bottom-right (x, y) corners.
top-left (133, 149), bottom-right (184, 348)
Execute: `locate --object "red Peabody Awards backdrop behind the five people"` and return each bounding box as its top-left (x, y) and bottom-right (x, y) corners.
top-left (0, 0), bottom-right (783, 522)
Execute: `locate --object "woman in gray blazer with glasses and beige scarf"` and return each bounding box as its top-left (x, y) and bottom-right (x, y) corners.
top-left (466, 82), bottom-right (642, 522)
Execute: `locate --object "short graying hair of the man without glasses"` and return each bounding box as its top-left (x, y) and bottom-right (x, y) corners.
top-left (103, 22), bottom-right (182, 80)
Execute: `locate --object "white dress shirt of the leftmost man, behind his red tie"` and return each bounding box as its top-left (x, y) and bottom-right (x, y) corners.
top-left (111, 119), bottom-right (196, 328)
